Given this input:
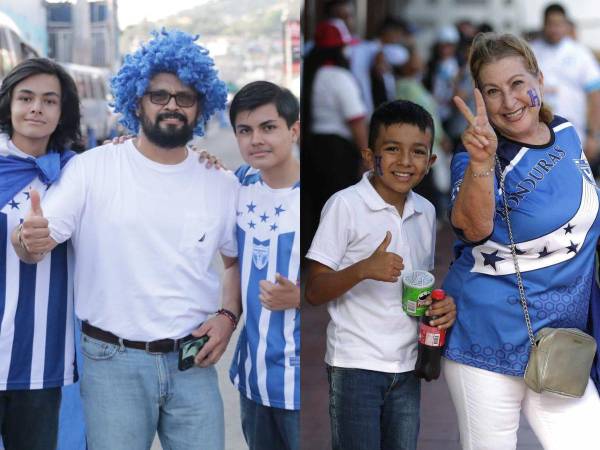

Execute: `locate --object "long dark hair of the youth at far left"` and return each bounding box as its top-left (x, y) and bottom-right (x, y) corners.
top-left (0, 58), bottom-right (81, 152)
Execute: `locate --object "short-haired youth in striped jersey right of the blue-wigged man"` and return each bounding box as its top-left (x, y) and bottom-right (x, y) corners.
top-left (229, 81), bottom-right (300, 450)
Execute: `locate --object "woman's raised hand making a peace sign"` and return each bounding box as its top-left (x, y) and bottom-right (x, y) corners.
top-left (453, 88), bottom-right (498, 164)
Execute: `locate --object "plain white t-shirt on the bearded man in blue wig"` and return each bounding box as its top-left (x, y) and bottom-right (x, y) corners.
top-left (42, 141), bottom-right (238, 341)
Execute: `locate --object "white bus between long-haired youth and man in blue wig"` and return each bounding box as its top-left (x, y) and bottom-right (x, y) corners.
top-left (61, 63), bottom-right (117, 148)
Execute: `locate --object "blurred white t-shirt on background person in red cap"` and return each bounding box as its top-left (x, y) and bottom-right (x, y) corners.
top-left (311, 66), bottom-right (366, 141)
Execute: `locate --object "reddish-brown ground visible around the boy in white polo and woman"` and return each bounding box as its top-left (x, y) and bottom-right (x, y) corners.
top-left (301, 226), bottom-right (542, 450)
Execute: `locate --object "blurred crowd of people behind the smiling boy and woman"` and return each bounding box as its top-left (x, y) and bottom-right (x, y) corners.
top-left (301, 0), bottom-right (600, 253)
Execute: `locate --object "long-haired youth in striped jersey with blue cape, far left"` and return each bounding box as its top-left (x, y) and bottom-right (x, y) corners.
top-left (0, 58), bottom-right (84, 450)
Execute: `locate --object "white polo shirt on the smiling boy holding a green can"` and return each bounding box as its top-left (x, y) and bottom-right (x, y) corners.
top-left (307, 173), bottom-right (435, 373)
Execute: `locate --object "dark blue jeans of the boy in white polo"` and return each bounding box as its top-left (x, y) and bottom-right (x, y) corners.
top-left (327, 366), bottom-right (421, 450)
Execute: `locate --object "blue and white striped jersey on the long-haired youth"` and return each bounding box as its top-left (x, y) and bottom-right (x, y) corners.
top-left (0, 163), bottom-right (77, 390)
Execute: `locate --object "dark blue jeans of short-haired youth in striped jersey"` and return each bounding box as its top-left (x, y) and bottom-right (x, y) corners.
top-left (240, 394), bottom-right (300, 450)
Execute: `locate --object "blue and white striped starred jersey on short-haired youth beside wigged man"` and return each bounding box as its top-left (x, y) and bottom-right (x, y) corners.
top-left (229, 166), bottom-right (300, 409)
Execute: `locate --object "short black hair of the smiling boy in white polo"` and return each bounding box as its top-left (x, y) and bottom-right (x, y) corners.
top-left (369, 100), bottom-right (435, 151)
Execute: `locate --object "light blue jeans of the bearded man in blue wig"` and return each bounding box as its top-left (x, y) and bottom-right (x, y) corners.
top-left (81, 335), bottom-right (225, 450)
